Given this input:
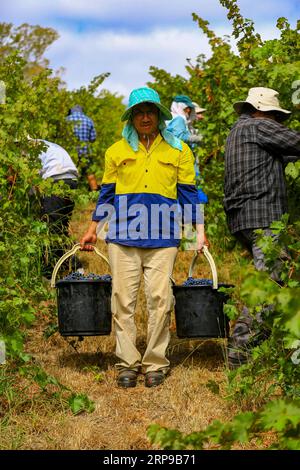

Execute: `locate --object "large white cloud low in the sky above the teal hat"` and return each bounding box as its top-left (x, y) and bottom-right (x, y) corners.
top-left (47, 25), bottom-right (278, 98)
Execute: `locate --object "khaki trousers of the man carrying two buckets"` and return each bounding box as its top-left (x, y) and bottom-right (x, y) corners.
top-left (108, 243), bottom-right (177, 373)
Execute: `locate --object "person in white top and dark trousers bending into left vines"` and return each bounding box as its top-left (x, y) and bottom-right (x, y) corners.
top-left (36, 139), bottom-right (81, 279)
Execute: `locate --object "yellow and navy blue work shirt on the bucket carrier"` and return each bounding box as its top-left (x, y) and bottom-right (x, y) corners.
top-left (93, 134), bottom-right (203, 248)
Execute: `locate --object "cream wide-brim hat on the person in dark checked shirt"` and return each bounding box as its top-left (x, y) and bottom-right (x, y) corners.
top-left (233, 87), bottom-right (291, 119)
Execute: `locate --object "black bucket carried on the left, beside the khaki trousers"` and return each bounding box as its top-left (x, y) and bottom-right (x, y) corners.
top-left (56, 280), bottom-right (111, 336)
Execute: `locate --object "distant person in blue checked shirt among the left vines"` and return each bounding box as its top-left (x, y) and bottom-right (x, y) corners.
top-left (66, 105), bottom-right (98, 191)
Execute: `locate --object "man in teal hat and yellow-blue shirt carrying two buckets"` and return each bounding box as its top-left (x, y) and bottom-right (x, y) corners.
top-left (80, 88), bottom-right (205, 387)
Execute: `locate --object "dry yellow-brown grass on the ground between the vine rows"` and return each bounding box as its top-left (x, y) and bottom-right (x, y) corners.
top-left (1, 203), bottom-right (262, 450)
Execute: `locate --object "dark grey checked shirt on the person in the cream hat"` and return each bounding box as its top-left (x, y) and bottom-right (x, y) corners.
top-left (224, 114), bottom-right (300, 233)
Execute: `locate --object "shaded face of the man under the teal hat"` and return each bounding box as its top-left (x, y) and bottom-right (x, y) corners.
top-left (132, 103), bottom-right (158, 135)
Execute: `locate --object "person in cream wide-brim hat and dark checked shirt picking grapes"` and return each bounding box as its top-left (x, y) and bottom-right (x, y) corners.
top-left (224, 87), bottom-right (300, 368)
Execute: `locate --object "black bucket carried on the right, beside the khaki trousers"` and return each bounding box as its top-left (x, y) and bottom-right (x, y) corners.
top-left (173, 284), bottom-right (232, 338)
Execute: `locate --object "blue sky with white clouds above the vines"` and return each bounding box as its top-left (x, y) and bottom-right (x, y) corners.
top-left (0, 0), bottom-right (300, 101)
